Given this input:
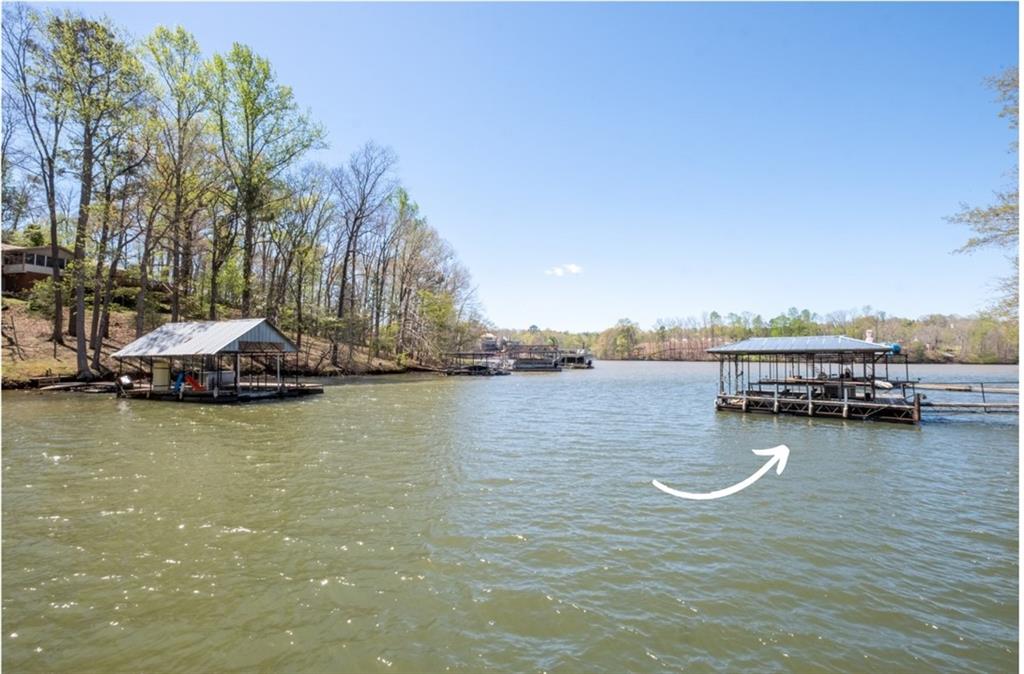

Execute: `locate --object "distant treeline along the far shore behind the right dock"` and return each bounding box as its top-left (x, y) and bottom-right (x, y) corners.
top-left (499, 307), bottom-right (1019, 364)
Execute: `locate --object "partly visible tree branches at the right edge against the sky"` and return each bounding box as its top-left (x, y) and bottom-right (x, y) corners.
top-left (948, 66), bottom-right (1020, 319)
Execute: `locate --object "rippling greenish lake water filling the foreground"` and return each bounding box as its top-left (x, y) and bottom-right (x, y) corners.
top-left (2, 363), bottom-right (1019, 672)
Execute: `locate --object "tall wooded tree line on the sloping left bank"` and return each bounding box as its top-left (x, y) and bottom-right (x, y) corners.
top-left (2, 5), bottom-right (480, 378)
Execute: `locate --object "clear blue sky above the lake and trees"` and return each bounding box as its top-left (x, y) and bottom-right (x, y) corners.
top-left (61, 3), bottom-right (1018, 330)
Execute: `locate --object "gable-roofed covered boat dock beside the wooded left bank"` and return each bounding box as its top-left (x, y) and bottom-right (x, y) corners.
top-left (114, 319), bottom-right (324, 403)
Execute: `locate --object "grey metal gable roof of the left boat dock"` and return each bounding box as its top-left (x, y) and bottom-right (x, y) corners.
top-left (114, 319), bottom-right (297, 359)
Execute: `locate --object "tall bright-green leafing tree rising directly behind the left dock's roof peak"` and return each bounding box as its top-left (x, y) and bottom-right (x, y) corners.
top-left (206, 43), bottom-right (324, 317)
